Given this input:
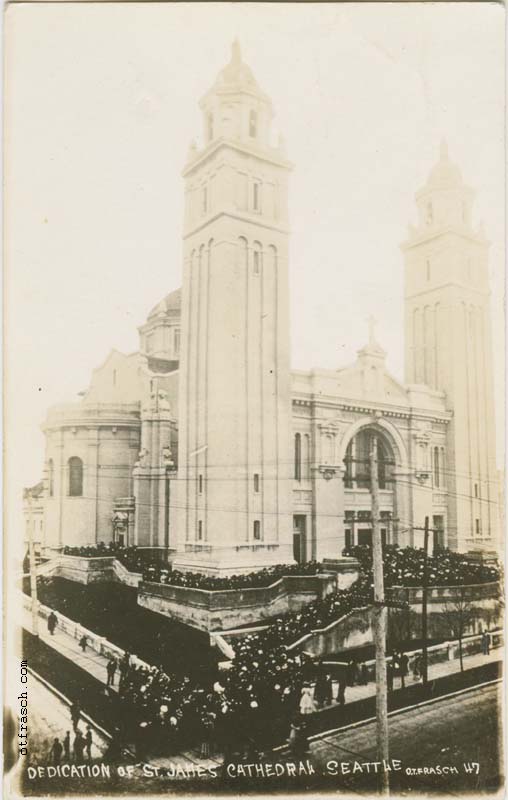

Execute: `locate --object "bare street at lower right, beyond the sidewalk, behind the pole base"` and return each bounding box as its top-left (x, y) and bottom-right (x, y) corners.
top-left (311, 683), bottom-right (502, 796)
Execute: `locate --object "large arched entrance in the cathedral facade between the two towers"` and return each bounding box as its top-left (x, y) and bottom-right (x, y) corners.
top-left (344, 425), bottom-right (396, 547)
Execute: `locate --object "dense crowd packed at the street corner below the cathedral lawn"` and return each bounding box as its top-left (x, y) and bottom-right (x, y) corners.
top-left (108, 634), bottom-right (315, 759)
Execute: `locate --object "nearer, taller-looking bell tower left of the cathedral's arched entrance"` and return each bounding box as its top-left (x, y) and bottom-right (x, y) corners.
top-left (171, 42), bottom-right (292, 574)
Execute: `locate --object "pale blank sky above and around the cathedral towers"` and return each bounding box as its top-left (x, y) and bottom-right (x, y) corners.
top-left (4, 3), bottom-right (505, 536)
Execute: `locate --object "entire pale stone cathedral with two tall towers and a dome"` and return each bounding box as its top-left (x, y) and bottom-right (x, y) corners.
top-left (28, 43), bottom-right (499, 574)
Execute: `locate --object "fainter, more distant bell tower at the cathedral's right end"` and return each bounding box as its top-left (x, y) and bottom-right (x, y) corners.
top-left (402, 142), bottom-right (499, 551)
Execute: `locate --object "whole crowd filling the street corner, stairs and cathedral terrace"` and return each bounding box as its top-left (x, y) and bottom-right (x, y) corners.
top-left (53, 546), bottom-right (499, 758)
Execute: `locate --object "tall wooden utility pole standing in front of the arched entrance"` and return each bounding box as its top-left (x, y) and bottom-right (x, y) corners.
top-left (370, 436), bottom-right (390, 795)
